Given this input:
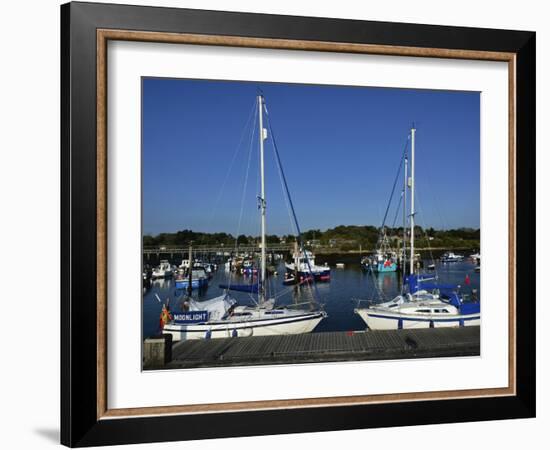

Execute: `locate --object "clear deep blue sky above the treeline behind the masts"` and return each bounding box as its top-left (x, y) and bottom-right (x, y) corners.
top-left (142, 78), bottom-right (480, 235)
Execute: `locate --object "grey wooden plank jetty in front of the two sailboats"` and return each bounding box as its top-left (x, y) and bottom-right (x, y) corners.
top-left (154, 326), bottom-right (480, 369)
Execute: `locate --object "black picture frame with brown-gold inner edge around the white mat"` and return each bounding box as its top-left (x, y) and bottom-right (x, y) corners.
top-left (61, 3), bottom-right (535, 446)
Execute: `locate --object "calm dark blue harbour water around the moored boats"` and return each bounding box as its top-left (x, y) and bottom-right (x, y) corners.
top-left (143, 255), bottom-right (481, 336)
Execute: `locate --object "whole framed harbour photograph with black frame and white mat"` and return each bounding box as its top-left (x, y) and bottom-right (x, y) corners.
top-left (61, 3), bottom-right (535, 447)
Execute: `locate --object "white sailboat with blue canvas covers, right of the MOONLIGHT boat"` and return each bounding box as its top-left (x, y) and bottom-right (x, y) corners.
top-left (355, 126), bottom-right (481, 330)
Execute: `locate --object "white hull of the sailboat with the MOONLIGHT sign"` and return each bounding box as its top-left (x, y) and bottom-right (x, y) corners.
top-left (163, 312), bottom-right (325, 341)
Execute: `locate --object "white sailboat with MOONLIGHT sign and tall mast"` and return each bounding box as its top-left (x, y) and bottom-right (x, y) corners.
top-left (163, 95), bottom-right (326, 341)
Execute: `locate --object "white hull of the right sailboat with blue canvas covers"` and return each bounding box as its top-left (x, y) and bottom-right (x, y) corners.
top-left (355, 308), bottom-right (481, 330)
